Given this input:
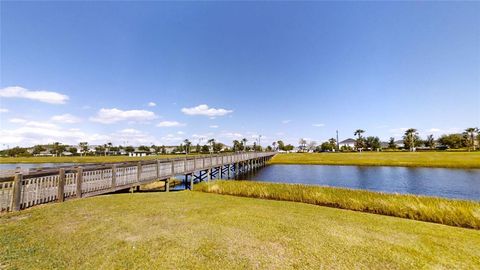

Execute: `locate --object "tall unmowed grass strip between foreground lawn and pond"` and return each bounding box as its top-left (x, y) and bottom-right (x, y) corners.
top-left (195, 180), bottom-right (480, 229)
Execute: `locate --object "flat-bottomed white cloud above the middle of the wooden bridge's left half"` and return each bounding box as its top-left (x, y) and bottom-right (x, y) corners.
top-left (90, 108), bottom-right (157, 124)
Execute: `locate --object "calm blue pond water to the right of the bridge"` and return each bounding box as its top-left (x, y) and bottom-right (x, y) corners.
top-left (240, 165), bottom-right (480, 200)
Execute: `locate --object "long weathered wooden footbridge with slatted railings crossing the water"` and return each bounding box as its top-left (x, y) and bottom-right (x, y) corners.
top-left (0, 152), bottom-right (275, 211)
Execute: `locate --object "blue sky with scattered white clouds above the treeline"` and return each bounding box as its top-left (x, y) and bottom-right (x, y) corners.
top-left (0, 1), bottom-right (480, 148)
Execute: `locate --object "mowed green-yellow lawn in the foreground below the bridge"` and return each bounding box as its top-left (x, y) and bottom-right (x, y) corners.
top-left (0, 191), bottom-right (480, 269)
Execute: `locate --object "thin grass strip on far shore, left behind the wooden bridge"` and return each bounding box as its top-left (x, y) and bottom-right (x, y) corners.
top-left (0, 155), bottom-right (192, 164)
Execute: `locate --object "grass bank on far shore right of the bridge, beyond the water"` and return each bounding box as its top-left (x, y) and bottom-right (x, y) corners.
top-left (270, 152), bottom-right (480, 168)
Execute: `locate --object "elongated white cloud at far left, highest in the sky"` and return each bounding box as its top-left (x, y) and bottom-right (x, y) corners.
top-left (0, 86), bottom-right (68, 104)
